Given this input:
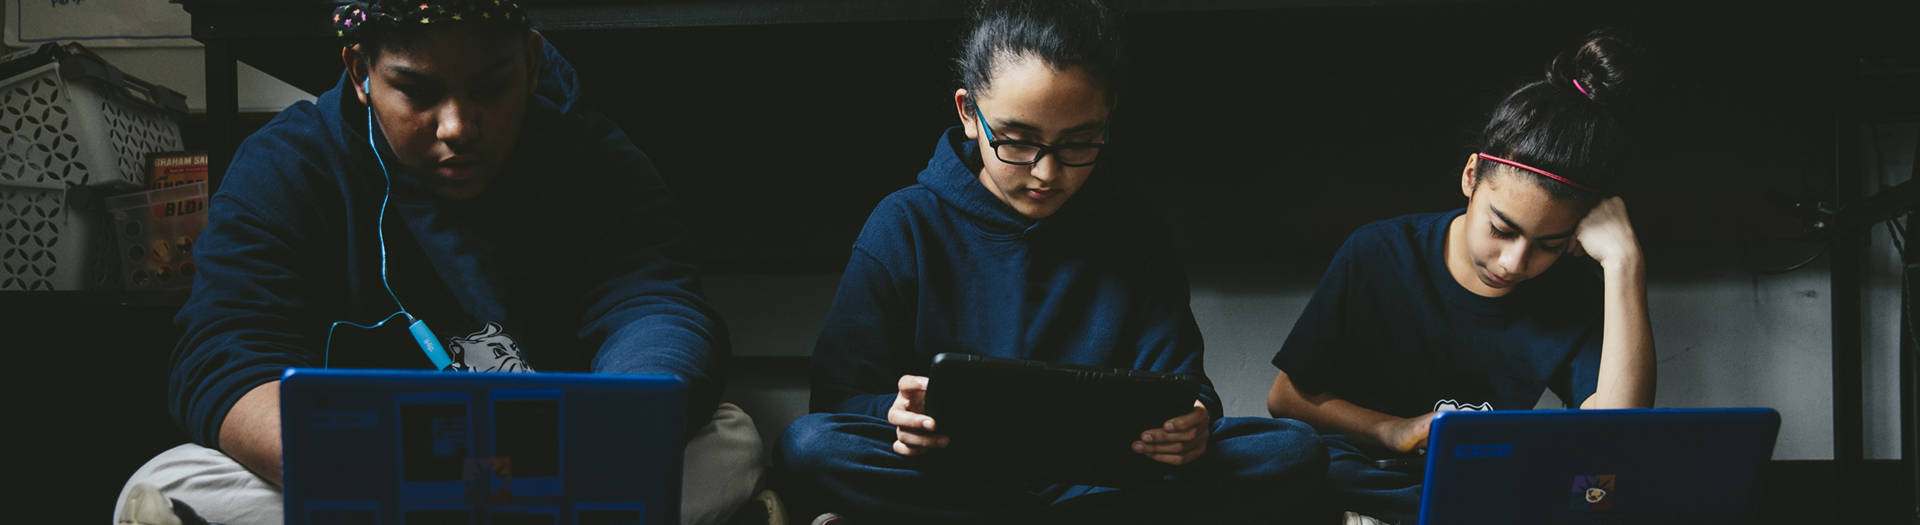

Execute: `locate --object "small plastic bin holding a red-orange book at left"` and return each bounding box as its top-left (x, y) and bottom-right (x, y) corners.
top-left (106, 183), bottom-right (207, 290)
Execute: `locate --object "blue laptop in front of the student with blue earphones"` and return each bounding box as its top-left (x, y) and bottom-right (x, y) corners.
top-left (280, 369), bottom-right (685, 525)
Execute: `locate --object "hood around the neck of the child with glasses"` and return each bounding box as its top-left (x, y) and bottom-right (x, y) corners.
top-left (920, 125), bottom-right (1117, 237)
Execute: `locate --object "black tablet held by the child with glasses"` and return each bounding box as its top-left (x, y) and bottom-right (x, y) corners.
top-left (925, 354), bottom-right (1200, 487)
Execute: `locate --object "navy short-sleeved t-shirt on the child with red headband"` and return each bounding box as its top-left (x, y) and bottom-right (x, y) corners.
top-left (1273, 210), bottom-right (1603, 417)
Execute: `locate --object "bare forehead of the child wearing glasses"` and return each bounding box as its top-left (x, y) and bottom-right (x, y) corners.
top-left (977, 56), bottom-right (1110, 127)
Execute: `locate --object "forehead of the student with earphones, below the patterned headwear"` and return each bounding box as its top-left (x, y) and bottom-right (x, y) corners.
top-left (374, 25), bottom-right (526, 79)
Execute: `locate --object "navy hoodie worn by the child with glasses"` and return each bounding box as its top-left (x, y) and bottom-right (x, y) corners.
top-left (812, 127), bottom-right (1221, 419)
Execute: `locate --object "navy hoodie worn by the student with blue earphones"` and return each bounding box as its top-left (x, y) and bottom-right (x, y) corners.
top-left (169, 46), bottom-right (730, 446)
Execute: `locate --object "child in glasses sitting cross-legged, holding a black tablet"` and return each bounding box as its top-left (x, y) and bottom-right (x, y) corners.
top-left (776, 0), bottom-right (1327, 523)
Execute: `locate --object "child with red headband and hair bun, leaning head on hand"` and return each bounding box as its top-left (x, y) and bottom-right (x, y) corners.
top-left (1267, 31), bottom-right (1655, 523)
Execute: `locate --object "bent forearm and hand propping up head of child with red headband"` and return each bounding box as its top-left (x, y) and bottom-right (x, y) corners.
top-left (1574, 196), bottom-right (1657, 408)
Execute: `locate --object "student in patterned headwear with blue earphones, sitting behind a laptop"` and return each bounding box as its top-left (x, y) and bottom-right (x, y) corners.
top-left (119, 0), bottom-right (762, 523)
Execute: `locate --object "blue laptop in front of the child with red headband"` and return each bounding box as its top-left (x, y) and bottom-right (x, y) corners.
top-left (1421, 408), bottom-right (1780, 525)
